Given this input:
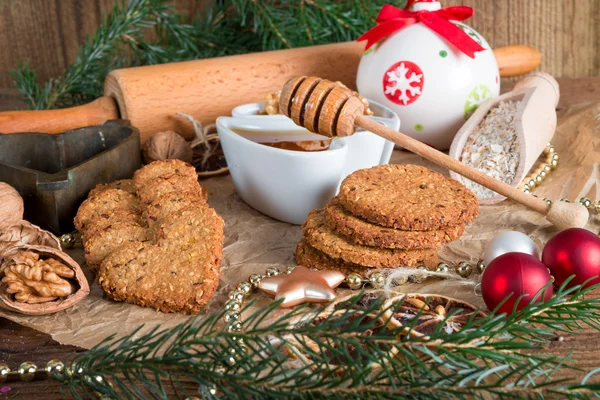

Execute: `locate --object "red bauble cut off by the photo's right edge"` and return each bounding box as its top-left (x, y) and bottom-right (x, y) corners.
top-left (542, 228), bottom-right (600, 286)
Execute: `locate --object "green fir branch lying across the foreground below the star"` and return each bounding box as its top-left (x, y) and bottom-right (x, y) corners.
top-left (48, 287), bottom-right (600, 399)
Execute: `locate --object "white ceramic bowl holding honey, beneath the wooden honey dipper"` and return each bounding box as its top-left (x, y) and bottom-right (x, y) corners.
top-left (217, 97), bottom-right (400, 225)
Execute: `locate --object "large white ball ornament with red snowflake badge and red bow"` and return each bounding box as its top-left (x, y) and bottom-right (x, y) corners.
top-left (356, 0), bottom-right (500, 150)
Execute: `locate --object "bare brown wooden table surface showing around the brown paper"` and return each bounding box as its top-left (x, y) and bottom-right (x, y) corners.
top-left (0, 77), bottom-right (600, 400)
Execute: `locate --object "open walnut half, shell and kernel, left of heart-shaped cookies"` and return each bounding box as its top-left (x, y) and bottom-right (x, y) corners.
top-left (0, 245), bottom-right (90, 315)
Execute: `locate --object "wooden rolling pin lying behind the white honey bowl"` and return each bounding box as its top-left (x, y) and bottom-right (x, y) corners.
top-left (0, 42), bottom-right (541, 142)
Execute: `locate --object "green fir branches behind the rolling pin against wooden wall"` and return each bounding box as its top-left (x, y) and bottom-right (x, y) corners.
top-left (11, 0), bottom-right (405, 109)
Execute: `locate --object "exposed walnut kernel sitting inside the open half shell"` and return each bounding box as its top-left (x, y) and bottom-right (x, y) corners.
top-left (2, 251), bottom-right (75, 304)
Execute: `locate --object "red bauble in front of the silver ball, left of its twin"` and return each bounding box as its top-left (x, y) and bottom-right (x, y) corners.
top-left (481, 253), bottom-right (554, 314)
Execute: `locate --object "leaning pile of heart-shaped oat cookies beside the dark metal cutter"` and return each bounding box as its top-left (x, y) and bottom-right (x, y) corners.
top-left (75, 160), bottom-right (223, 313)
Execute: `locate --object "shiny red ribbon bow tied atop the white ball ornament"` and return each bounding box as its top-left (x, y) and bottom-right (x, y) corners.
top-left (358, 4), bottom-right (485, 58)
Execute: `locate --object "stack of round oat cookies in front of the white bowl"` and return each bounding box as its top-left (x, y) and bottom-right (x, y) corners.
top-left (296, 165), bottom-right (479, 273)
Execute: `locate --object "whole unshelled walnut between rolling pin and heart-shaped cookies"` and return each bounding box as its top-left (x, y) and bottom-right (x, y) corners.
top-left (142, 131), bottom-right (194, 164)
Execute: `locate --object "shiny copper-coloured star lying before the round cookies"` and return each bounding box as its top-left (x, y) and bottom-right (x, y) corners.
top-left (258, 266), bottom-right (346, 308)
